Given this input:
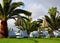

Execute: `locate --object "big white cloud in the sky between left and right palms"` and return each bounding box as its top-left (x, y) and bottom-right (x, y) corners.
top-left (27, 3), bottom-right (47, 19)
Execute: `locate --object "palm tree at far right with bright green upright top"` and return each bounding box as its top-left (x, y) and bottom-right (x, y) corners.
top-left (45, 7), bottom-right (60, 37)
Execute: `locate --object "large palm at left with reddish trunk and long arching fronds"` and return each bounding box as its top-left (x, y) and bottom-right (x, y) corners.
top-left (0, 0), bottom-right (31, 38)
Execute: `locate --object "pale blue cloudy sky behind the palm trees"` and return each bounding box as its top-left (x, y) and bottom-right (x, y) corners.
top-left (0, 0), bottom-right (60, 30)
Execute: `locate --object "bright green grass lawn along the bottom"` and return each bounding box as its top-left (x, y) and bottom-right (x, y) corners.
top-left (0, 38), bottom-right (60, 43)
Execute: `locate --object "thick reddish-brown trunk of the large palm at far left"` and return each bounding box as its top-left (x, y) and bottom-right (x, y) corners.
top-left (0, 20), bottom-right (8, 38)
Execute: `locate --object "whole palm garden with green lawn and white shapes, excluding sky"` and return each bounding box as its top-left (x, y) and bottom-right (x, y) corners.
top-left (0, 0), bottom-right (60, 43)
